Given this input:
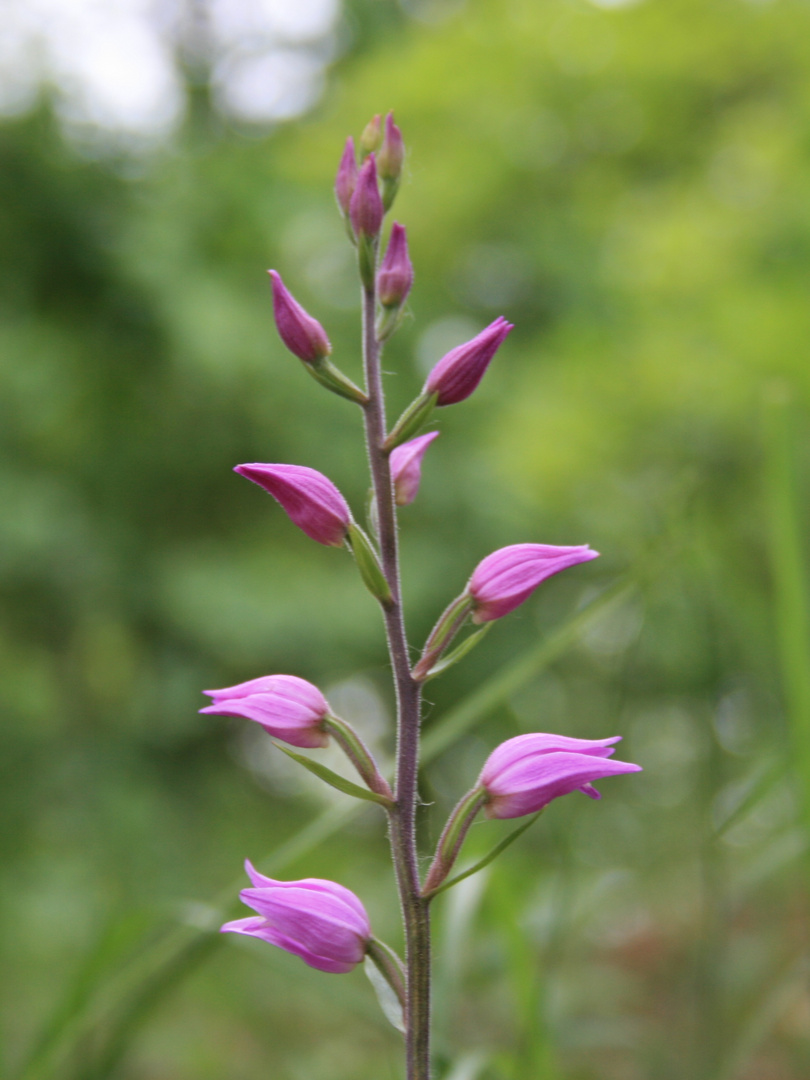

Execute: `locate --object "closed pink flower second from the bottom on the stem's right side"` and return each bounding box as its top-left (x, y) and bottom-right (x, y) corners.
top-left (467, 543), bottom-right (599, 622)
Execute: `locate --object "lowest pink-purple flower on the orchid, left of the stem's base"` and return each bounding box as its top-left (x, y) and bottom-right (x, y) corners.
top-left (220, 862), bottom-right (372, 974)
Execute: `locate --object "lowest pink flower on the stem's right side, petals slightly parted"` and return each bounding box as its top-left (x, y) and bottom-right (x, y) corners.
top-left (478, 733), bottom-right (642, 818)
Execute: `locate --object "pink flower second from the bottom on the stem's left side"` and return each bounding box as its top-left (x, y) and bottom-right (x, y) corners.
top-left (200, 675), bottom-right (329, 748)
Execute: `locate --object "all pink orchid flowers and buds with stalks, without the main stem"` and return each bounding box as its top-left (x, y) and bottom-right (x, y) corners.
top-left (207, 113), bottom-right (639, 981)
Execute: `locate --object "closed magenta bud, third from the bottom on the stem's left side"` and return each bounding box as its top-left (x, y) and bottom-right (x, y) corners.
top-left (233, 462), bottom-right (352, 548)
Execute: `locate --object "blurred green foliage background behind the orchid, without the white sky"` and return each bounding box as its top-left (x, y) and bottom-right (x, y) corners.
top-left (0, 0), bottom-right (810, 1080)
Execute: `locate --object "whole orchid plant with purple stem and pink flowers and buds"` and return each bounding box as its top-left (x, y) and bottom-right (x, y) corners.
top-left (202, 113), bottom-right (639, 1080)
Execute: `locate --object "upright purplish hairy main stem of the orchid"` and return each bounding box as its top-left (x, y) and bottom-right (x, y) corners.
top-left (363, 272), bottom-right (430, 1080)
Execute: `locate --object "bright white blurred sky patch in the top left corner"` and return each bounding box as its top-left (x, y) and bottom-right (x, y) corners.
top-left (0, 0), bottom-right (339, 139)
